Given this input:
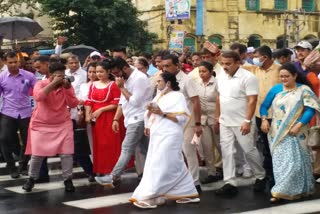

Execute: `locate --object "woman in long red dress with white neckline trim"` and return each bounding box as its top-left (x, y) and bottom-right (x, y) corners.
top-left (85, 62), bottom-right (125, 174)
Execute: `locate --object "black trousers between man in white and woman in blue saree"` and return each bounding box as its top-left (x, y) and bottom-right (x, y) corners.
top-left (256, 117), bottom-right (273, 178)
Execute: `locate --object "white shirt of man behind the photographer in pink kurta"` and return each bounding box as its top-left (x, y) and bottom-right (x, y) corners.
top-left (65, 68), bottom-right (87, 120)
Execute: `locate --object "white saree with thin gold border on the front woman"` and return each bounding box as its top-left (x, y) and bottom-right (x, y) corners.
top-left (130, 91), bottom-right (198, 201)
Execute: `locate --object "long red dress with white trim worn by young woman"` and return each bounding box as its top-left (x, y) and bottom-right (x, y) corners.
top-left (86, 82), bottom-right (125, 174)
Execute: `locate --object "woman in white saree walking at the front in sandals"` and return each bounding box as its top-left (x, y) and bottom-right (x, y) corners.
top-left (130, 72), bottom-right (200, 208)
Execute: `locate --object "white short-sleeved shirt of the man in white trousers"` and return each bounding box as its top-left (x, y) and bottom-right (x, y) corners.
top-left (217, 67), bottom-right (259, 126)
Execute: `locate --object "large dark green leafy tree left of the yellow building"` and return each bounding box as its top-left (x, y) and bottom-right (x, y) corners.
top-left (38, 0), bottom-right (156, 50)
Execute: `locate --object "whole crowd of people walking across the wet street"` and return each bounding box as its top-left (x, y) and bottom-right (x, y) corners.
top-left (0, 37), bottom-right (320, 208)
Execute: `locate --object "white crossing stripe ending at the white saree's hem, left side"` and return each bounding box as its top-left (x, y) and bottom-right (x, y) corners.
top-left (63, 192), bottom-right (132, 210)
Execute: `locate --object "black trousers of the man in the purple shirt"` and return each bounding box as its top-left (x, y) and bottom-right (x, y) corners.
top-left (0, 114), bottom-right (30, 169)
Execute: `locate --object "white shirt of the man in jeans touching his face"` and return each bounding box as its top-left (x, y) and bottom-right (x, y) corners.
top-left (119, 69), bottom-right (153, 127)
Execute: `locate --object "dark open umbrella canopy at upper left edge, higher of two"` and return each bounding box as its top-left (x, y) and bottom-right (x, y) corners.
top-left (0, 17), bottom-right (43, 40)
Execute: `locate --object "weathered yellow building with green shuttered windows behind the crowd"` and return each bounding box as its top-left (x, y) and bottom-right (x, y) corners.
top-left (133, 0), bottom-right (320, 50)
